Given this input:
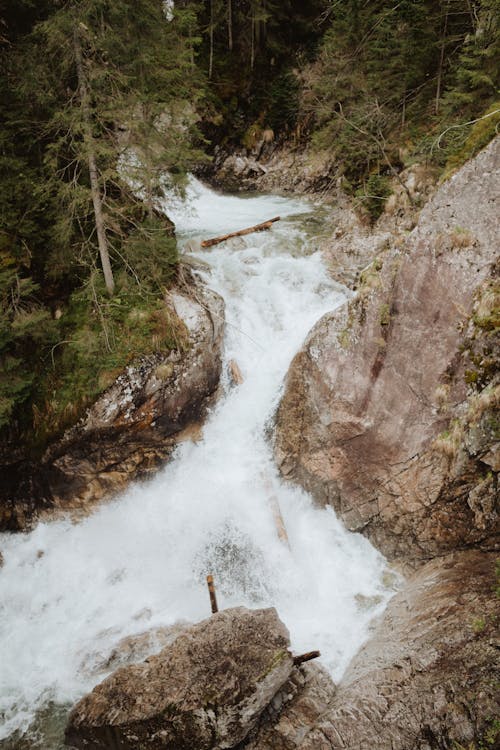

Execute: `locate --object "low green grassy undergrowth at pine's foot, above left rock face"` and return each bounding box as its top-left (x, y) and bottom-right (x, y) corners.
top-left (32, 280), bottom-right (189, 446)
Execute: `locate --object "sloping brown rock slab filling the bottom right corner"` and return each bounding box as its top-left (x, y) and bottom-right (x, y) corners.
top-left (248, 551), bottom-right (500, 750)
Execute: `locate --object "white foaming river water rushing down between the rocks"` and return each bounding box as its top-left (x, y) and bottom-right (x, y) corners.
top-left (0, 180), bottom-right (398, 750)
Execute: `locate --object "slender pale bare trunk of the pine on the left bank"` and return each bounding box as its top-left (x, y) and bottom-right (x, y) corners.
top-left (73, 22), bottom-right (115, 296)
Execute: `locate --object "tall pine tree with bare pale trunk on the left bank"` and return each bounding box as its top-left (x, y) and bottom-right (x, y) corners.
top-left (26, 0), bottom-right (206, 294)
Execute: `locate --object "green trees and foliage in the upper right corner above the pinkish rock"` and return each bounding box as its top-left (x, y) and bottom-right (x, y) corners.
top-left (300, 0), bottom-right (500, 187)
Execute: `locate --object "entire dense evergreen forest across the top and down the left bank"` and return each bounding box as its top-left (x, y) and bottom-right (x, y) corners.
top-left (0, 0), bottom-right (500, 451)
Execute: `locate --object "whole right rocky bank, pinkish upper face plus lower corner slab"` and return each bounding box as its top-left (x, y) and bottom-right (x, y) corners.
top-left (270, 138), bottom-right (500, 750)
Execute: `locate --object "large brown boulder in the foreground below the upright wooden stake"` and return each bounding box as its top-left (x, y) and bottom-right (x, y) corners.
top-left (66, 608), bottom-right (293, 750)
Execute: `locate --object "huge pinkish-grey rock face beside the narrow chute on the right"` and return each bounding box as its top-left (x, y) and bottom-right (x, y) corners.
top-left (276, 138), bottom-right (500, 560)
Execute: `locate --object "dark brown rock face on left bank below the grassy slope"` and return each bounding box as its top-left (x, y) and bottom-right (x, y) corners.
top-left (0, 283), bottom-right (224, 530)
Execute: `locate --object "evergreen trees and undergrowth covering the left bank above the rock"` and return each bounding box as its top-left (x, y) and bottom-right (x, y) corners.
top-left (0, 0), bottom-right (203, 446)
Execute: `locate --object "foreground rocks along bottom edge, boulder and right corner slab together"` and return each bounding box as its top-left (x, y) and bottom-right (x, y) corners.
top-left (66, 551), bottom-right (500, 750)
